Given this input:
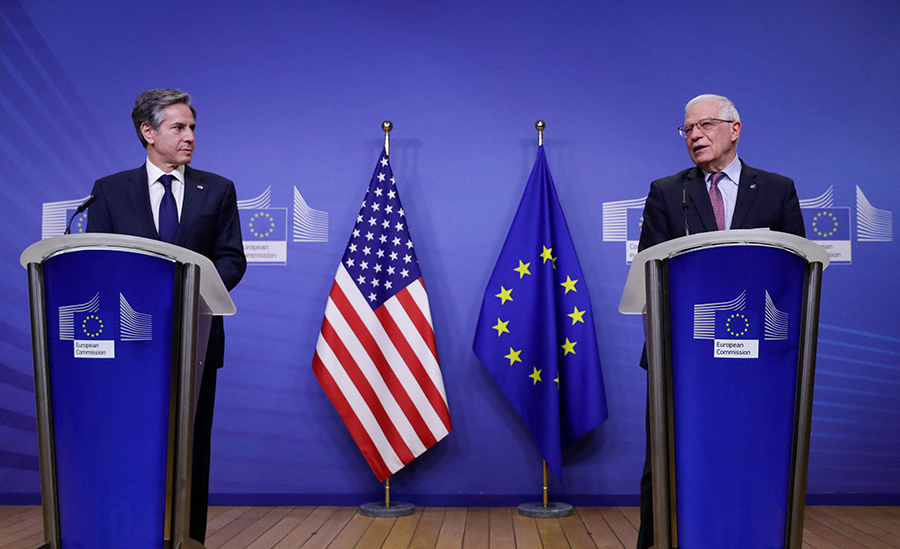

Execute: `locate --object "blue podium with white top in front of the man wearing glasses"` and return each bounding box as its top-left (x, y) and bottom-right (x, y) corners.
top-left (619, 229), bottom-right (829, 549)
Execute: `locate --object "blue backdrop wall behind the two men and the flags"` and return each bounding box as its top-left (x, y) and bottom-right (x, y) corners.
top-left (0, 0), bottom-right (900, 505)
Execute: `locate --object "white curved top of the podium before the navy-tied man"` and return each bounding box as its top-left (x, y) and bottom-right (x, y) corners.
top-left (19, 233), bottom-right (237, 316)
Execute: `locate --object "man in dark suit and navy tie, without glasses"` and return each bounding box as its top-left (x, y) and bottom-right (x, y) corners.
top-left (87, 90), bottom-right (247, 543)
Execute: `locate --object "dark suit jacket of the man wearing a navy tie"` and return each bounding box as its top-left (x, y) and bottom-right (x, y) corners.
top-left (87, 165), bottom-right (247, 368)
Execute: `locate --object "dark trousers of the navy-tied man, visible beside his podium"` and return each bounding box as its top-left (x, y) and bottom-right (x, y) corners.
top-left (190, 362), bottom-right (218, 543)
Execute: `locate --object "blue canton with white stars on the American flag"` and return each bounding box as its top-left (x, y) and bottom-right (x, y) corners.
top-left (341, 150), bottom-right (422, 310)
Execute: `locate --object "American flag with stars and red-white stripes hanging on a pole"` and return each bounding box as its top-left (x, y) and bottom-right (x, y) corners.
top-left (313, 146), bottom-right (451, 481)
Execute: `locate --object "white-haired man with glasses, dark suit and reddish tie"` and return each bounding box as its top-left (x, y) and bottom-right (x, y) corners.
top-left (637, 95), bottom-right (805, 549)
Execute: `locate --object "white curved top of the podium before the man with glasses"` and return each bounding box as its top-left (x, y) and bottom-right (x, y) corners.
top-left (619, 229), bottom-right (830, 315)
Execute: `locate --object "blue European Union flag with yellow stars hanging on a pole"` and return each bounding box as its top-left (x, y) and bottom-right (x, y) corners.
top-left (474, 146), bottom-right (608, 478)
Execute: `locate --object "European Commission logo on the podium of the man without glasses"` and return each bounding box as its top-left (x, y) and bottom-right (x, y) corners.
top-left (59, 292), bottom-right (153, 358)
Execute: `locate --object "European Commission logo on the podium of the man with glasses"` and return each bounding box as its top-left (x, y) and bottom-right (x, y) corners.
top-left (694, 290), bottom-right (790, 358)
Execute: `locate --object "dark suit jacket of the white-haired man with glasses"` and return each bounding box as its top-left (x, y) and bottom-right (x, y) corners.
top-left (636, 160), bottom-right (806, 370)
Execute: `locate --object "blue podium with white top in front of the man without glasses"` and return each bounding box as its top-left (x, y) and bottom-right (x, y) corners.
top-left (21, 234), bottom-right (235, 549)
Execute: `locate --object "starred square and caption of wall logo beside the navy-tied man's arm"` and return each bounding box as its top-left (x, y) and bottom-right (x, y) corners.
top-left (238, 186), bottom-right (287, 265)
